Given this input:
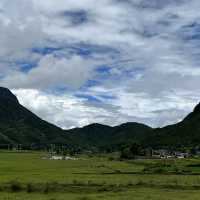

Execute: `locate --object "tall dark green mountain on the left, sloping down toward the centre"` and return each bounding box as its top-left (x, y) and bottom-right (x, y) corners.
top-left (0, 87), bottom-right (69, 145)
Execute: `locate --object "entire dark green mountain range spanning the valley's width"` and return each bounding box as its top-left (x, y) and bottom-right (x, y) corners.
top-left (0, 87), bottom-right (200, 150)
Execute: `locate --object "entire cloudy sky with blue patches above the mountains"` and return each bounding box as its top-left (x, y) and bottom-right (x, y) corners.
top-left (0, 0), bottom-right (200, 129)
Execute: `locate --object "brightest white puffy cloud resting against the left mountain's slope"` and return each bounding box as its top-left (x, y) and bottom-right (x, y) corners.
top-left (12, 89), bottom-right (119, 128)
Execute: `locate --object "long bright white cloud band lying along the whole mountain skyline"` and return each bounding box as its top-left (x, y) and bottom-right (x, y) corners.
top-left (12, 88), bottom-right (199, 129)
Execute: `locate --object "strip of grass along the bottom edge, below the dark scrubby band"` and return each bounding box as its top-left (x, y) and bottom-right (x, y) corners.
top-left (0, 188), bottom-right (200, 200)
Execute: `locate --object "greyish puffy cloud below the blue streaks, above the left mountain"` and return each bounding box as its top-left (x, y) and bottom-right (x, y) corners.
top-left (1, 55), bottom-right (97, 89)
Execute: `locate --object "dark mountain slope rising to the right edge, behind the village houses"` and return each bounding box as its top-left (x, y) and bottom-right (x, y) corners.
top-left (143, 104), bottom-right (200, 148)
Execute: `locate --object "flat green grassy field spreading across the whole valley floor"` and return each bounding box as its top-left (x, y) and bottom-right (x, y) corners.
top-left (0, 152), bottom-right (200, 200)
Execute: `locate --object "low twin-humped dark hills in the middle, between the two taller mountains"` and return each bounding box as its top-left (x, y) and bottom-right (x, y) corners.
top-left (66, 123), bottom-right (151, 150)
